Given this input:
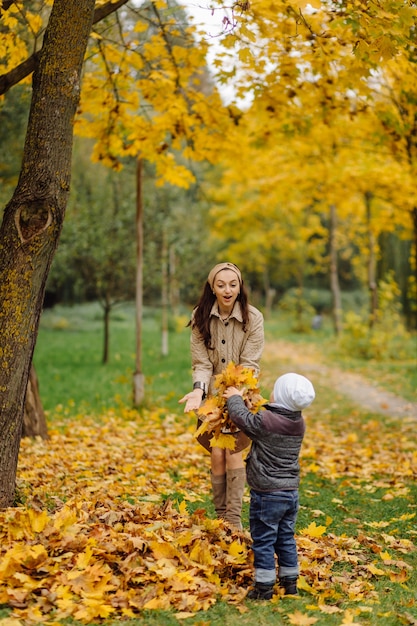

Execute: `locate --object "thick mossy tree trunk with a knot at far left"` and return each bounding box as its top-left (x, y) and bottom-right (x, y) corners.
top-left (0, 0), bottom-right (95, 507)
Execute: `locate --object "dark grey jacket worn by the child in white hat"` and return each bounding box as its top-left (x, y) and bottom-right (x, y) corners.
top-left (227, 395), bottom-right (305, 492)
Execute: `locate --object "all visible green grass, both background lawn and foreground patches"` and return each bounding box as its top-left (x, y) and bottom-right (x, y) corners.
top-left (23, 305), bottom-right (417, 626)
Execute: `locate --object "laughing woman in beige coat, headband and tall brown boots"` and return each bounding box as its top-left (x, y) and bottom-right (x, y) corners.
top-left (179, 263), bottom-right (264, 529)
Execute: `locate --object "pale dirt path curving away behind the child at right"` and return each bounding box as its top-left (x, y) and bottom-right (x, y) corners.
top-left (263, 341), bottom-right (417, 419)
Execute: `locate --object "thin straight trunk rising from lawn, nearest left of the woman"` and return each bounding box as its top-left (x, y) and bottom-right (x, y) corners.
top-left (133, 159), bottom-right (145, 406)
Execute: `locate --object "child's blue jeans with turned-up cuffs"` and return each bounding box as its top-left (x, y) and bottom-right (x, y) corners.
top-left (249, 490), bottom-right (299, 583)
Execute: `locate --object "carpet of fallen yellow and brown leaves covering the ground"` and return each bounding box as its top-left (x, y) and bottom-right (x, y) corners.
top-left (0, 382), bottom-right (417, 626)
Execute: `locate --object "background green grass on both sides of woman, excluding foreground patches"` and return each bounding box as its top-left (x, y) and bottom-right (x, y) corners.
top-left (34, 304), bottom-right (417, 415)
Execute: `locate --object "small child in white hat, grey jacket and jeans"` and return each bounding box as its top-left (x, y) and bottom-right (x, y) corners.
top-left (223, 373), bottom-right (315, 600)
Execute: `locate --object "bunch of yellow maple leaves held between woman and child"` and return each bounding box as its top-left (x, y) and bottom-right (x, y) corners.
top-left (195, 361), bottom-right (266, 450)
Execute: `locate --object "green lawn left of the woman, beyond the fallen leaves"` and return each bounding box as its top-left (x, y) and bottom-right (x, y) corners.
top-left (34, 304), bottom-right (191, 415)
